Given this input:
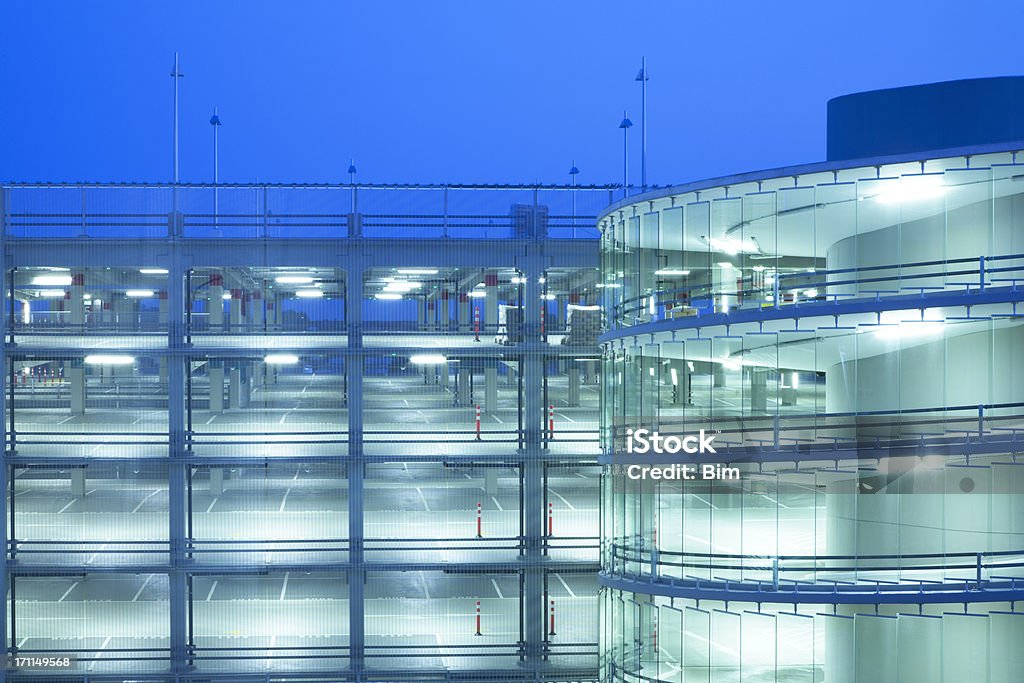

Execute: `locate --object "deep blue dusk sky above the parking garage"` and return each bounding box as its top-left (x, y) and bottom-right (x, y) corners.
top-left (0, 0), bottom-right (1024, 184)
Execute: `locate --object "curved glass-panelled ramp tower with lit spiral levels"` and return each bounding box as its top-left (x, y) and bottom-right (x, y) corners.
top-left (599, 150), bottom-right (1024, 683)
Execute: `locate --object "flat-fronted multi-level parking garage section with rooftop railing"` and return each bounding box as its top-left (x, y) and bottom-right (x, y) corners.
top-left (0, 184), bottom-right (609, 682)
